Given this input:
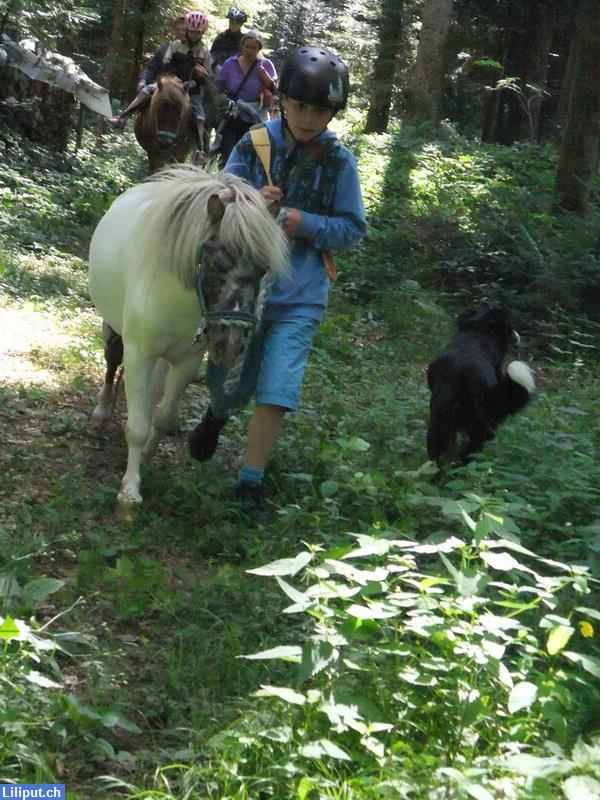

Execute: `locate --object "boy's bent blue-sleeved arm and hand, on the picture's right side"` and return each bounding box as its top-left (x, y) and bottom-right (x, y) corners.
top-left (290, 153), bottom-right (367, 250)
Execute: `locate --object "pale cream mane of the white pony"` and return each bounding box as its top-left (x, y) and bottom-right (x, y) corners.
top-left (132, 164), bottom-right (288, 288)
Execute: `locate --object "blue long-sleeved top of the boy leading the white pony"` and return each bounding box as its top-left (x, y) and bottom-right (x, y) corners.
top-left (225, 119), bottom-right (366, 320)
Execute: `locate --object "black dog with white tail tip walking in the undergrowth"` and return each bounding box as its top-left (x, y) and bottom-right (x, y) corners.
top-left (427, 308), bottom-right (535, 463)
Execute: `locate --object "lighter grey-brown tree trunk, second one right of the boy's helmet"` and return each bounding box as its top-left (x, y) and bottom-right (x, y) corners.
top-left (406, 0), bottom-right (454, 124)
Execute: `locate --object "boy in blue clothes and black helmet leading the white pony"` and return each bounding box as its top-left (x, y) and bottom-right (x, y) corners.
top-left (190, 47), bottom-right (366, 520)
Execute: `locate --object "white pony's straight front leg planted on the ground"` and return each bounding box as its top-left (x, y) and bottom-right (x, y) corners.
top-left (117, 343), bottom-right (155, 506)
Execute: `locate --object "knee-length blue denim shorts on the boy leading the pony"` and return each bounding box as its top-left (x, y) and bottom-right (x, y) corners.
top-left (206, 317), bottom-right (319, 419)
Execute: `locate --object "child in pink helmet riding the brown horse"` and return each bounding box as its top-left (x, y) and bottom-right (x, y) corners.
top-left (108, 11), bottom-right (212, 163)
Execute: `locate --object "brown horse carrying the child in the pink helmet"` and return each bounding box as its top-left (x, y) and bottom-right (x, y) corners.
top-left (133, 75), bottom-right (196, 173)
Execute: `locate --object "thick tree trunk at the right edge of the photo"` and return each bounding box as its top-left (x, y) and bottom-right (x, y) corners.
top-left (554, 0), bottom-right (600, 215)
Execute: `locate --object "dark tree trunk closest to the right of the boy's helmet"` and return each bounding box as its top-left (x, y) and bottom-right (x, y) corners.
top-left (365, 0), bottom-right (403, 133)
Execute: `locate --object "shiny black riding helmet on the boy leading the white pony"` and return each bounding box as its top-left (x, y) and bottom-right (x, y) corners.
top-left (278, 45), bottom-right (350, 114)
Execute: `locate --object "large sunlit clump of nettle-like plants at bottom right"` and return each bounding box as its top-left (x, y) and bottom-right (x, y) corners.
top-left (205, 496), bottom-right (600, 800)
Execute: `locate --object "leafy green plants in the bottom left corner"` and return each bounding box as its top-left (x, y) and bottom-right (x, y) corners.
top-left (0, 572), bottom-right (138, 783)
